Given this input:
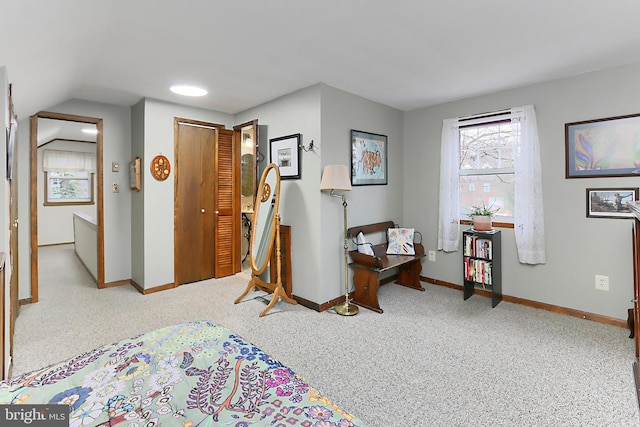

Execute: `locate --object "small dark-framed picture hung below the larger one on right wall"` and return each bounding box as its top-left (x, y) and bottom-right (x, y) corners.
top-left (587, 188), bottom-right (638, 218)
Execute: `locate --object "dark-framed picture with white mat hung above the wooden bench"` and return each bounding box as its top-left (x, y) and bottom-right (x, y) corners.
top-left (351, 130), bottom-right (388, 185)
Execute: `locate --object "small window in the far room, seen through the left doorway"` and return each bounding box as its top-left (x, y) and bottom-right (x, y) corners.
top-left (44, 171), bottom-right (93, 206)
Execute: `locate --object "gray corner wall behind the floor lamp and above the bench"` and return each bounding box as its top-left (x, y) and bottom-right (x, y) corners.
top-left (235, 84), bottom-right (404, 304)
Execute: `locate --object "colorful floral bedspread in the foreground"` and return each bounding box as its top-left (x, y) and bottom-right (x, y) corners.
top-left (0, 321), bottom-right (364, 427)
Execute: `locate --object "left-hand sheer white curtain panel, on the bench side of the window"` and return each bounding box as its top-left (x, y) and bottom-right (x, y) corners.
top-left (438, 118), bottom-right (460, 252)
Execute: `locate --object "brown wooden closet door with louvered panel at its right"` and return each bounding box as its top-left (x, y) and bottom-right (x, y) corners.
top-left (174, 119), bottom-right (240, 285)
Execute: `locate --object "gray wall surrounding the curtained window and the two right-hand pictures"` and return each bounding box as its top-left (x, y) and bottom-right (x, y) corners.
top-left (404, 64), bottom-right (640, 319)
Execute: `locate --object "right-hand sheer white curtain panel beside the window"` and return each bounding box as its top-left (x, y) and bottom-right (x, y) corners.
top-left (511, 105), bottom-right (546, 264)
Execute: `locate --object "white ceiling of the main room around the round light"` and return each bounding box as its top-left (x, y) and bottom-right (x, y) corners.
top-left (0, 0), bottom-right (640, 118)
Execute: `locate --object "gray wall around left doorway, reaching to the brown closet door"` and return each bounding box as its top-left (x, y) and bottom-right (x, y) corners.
top-left (19, 99), bottom-right (238, 299)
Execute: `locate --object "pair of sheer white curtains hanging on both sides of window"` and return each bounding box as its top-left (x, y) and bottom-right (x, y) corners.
top-left (438, 105), bottom-right (546, 264)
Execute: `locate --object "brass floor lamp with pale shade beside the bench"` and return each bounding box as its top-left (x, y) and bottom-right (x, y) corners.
top-left (320, 165), bottom-right (358, 316)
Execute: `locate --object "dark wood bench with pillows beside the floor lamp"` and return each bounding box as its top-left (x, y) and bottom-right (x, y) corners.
top-left (347, 221), bottom-right (425, 313)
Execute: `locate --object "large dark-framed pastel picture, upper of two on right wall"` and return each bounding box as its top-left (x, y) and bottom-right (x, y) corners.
top-left (564, 114), bottom-right (640, 178)
